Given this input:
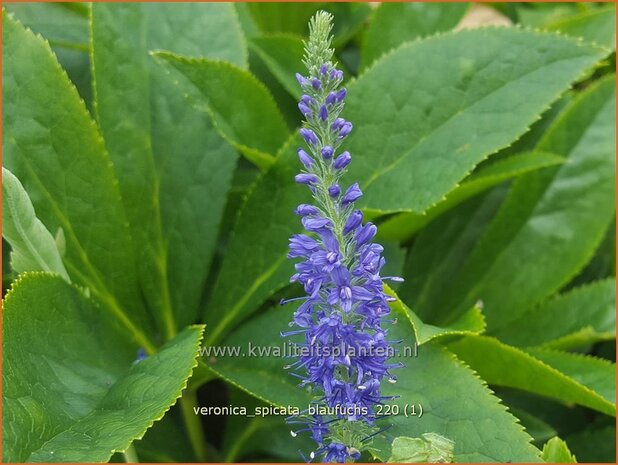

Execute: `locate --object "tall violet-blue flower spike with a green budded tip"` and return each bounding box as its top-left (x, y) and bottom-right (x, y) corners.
top-left (282, 11), bottom-right (401, 463)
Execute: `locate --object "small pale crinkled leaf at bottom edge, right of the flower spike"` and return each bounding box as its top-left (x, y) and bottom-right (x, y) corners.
top-left (388, 433), bottom-right (455, 463)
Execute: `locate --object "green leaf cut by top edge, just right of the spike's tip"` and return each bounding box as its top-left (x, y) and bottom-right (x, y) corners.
top-left (361, 2), bottom-right (468, 68)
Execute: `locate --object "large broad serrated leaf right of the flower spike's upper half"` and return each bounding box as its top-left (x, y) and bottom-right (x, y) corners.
top-left (344, 28), bottom-right (603, 213)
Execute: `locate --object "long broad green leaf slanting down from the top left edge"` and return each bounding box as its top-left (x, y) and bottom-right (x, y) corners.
top-left (2, 12), bottom-right (152, 348)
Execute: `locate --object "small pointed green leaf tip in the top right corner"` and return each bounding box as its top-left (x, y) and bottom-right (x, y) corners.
top-left (541, 5), bottom-right (616, 50)
